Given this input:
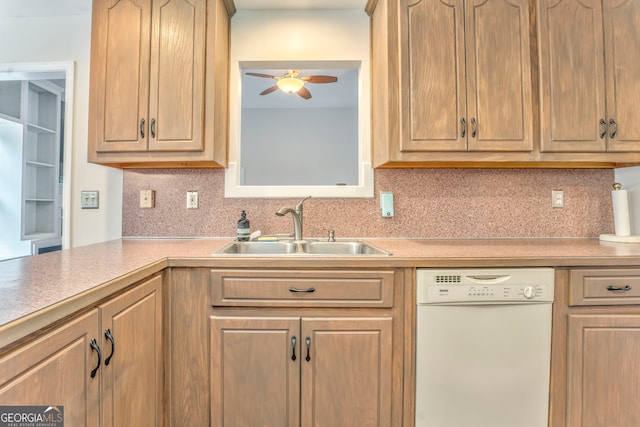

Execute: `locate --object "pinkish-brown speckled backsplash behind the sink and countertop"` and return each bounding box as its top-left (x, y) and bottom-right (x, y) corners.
top-left (122, 169), bottom-right (614, 238)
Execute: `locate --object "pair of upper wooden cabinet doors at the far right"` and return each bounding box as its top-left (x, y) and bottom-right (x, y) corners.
top-left (538, 0), bottom-right (640, 152)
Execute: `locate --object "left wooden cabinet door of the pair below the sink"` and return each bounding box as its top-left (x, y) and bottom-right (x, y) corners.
top-left (210, 316), bottom-right (300, 427)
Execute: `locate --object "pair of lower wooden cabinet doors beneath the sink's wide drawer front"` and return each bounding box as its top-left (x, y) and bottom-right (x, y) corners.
top-left (210, 313), bottom-right (393, 427)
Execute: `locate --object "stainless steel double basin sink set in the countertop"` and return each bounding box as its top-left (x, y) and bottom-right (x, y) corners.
top-left (216, 240), bottom-right (391, 256)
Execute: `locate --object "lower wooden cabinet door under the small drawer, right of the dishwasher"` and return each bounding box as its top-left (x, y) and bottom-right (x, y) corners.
top-left (567, 314), bottom-right (640, 427)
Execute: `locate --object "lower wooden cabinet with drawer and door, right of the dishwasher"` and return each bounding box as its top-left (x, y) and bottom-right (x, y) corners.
top-left (550, 268), bottom-right (640, 427)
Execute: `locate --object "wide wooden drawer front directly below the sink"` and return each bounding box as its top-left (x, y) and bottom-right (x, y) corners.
top-left (210, 270), bottom-right (394, 307)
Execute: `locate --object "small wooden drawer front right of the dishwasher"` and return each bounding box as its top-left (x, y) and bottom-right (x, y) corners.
top-left (569, 268), bottom-right (640, 305)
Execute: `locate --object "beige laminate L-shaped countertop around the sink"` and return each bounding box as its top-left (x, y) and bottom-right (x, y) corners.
top-left (0, 239), bottom-right (640, 350)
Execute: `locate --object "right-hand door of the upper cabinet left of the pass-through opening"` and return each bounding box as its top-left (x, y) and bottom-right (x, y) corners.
top-left (149, 0), bottom-right (207, 151)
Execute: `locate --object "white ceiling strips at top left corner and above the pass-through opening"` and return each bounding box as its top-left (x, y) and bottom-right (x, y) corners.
top-left (0, 0), bottom-right (367, 17)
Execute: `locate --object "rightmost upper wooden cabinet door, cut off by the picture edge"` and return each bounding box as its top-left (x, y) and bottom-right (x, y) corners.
top-left (603, 0), bottom-right (640, 151)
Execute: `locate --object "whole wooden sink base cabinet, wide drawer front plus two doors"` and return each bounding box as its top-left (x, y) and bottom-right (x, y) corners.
top-left (209, 269), bottom-right (403, 427)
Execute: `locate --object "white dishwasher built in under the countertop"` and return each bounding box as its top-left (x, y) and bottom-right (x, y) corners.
top-left (415, 268), bottom-right (554, 427)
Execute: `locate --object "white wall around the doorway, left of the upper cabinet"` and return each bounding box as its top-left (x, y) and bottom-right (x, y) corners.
top-left (0, 14), bottom-right (122, 247)
